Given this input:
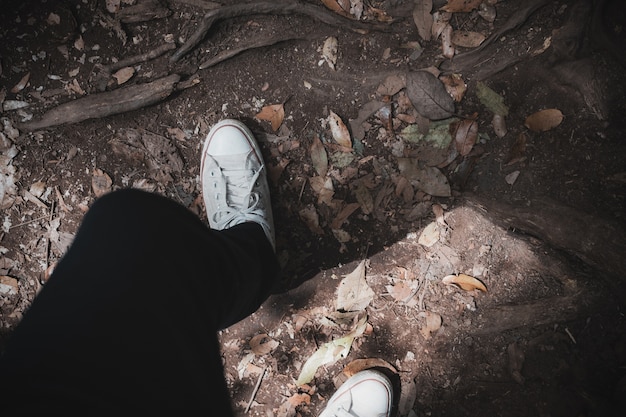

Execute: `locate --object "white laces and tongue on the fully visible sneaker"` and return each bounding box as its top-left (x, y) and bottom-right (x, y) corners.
top-left (213, 165), bottom-right (269, 229)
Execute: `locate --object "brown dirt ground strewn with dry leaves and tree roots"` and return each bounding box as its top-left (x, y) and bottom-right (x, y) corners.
top-left (0, 0), bottom-right (626, 417)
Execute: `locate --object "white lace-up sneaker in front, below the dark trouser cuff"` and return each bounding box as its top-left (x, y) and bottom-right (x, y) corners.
top-left (200, 119), bottom-right (276, 247)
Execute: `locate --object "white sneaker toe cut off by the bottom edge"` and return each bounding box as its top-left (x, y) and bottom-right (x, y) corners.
top-left (319, 370), bottom-right (393, 417)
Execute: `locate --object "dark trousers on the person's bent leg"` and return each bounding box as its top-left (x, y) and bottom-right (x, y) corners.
top-left (0, 190), bottom-right (279, 416)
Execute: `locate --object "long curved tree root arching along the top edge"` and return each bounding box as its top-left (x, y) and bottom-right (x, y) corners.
top-left (170, 1), bottom-right (390, 62)
